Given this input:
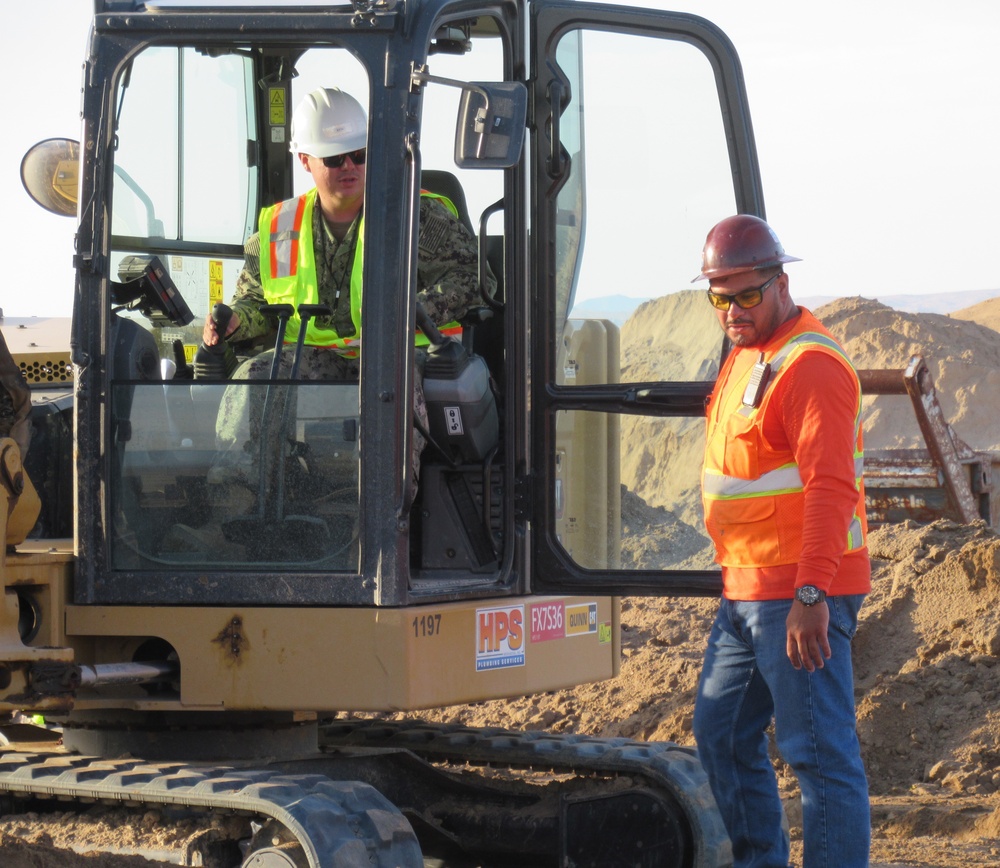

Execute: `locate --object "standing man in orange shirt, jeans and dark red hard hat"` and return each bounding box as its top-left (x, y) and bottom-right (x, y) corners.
top-left (694, 215), bottom-right (871, 868)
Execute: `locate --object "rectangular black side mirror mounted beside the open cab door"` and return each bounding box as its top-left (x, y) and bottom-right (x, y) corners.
top-left (455, 81), bottom-right (528, 169)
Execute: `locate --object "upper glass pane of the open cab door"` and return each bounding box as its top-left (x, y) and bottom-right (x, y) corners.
top-left (554, 31), bottom-right (736, 385)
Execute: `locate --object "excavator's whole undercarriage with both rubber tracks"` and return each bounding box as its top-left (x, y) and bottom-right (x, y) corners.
top-left (0, 718), bottom-right (732, 868)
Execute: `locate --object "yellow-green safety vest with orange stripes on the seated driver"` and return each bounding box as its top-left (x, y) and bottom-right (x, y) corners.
top-left (258, 188), bottom-right (462, 358)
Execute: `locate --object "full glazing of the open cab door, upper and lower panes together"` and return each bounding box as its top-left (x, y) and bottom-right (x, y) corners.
top-left (543, 30), bottom-right (737, 577)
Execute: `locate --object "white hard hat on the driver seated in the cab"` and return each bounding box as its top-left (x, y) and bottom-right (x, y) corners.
top-left (289, 87), bottom-right (368, 157)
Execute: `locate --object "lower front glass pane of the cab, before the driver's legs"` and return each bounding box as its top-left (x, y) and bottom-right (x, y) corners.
top-left (111, 381), bottom-right (359, 572)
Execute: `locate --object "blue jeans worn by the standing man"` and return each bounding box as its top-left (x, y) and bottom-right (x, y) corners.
top-left (694, 594), bottom-right (871, 868)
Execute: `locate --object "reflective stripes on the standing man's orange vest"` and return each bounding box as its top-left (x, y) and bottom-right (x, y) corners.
top-left (702, 322), bottom-right (865, 552)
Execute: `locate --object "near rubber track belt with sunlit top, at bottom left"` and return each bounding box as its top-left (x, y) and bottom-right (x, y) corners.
top-left (0, 752), bottom-right (423, 868)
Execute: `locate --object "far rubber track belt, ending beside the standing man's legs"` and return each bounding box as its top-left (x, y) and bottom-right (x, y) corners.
top-left (320, 718), bottom-right (733, 868)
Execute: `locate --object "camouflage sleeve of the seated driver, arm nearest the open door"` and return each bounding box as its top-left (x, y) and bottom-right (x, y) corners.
top-left (417, 196), bottom-right (496, 325)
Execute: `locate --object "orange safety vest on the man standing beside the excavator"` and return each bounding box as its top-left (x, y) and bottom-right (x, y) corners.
top-left (702, 310), bottom-right (867, 567)
